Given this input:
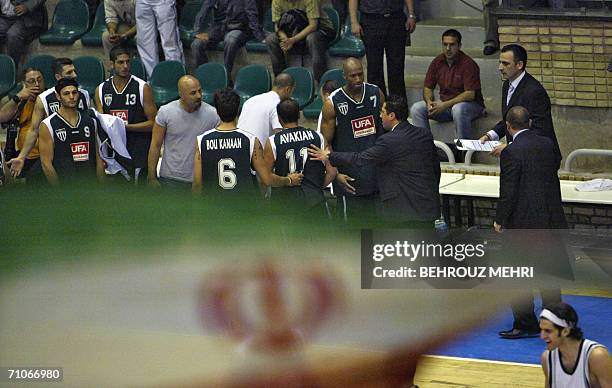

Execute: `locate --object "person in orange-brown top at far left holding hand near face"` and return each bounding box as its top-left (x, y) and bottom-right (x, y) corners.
top-left (0, 67), bottom-right (45, 182)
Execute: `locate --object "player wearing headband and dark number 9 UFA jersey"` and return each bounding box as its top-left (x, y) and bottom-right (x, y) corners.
top-left (38, 78), bottom-right (104, 186)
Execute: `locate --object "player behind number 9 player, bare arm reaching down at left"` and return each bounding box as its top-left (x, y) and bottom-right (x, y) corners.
top-left (7, 58), bottom-right (90, 177)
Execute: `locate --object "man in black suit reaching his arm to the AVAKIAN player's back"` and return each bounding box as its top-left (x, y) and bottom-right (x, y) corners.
top-left (308, 95), bottom-right (440, 228)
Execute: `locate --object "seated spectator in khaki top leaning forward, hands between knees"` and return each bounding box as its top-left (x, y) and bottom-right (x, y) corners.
top-left (266, 0), bottom-right (335, 81)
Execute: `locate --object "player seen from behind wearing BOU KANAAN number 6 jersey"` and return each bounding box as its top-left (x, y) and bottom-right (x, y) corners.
top-left (192, 89), bottom-right (302, 201)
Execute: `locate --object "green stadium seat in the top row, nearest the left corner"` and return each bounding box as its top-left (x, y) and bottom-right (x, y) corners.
top-left (39, 0), bottom-right (89, 45)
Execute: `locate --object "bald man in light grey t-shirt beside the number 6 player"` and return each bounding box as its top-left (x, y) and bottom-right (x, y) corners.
top-left (148, 75), bottom-right (219, 191)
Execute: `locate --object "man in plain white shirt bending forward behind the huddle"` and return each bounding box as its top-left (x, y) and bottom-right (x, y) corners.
top-left (238, 73), bottom-right (295, 150)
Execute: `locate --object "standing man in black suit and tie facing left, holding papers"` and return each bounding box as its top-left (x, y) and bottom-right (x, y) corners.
top-left (480, 44), bottom-right (561, 165)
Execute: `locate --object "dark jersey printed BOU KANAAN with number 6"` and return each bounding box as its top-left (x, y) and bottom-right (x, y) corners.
top-left (197, 128), bottom-right (259, 199)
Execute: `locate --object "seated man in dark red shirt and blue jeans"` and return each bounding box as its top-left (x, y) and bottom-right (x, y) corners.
top-left (410, 29), bottom-right (484, 139)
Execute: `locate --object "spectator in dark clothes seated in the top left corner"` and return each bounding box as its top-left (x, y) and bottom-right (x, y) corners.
top-left (0, 0), bottom-right (47, 66)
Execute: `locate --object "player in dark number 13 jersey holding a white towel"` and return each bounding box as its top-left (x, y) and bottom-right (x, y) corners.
top-left (95, 46), bottom-right (157, 183)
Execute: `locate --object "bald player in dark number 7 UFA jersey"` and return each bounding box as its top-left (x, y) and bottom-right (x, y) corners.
top-left (321, 58), bottom-right (385, 223)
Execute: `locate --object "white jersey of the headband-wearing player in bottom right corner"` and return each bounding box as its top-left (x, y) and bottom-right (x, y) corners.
top-left (548, 338), bottom-right (604, 388)
